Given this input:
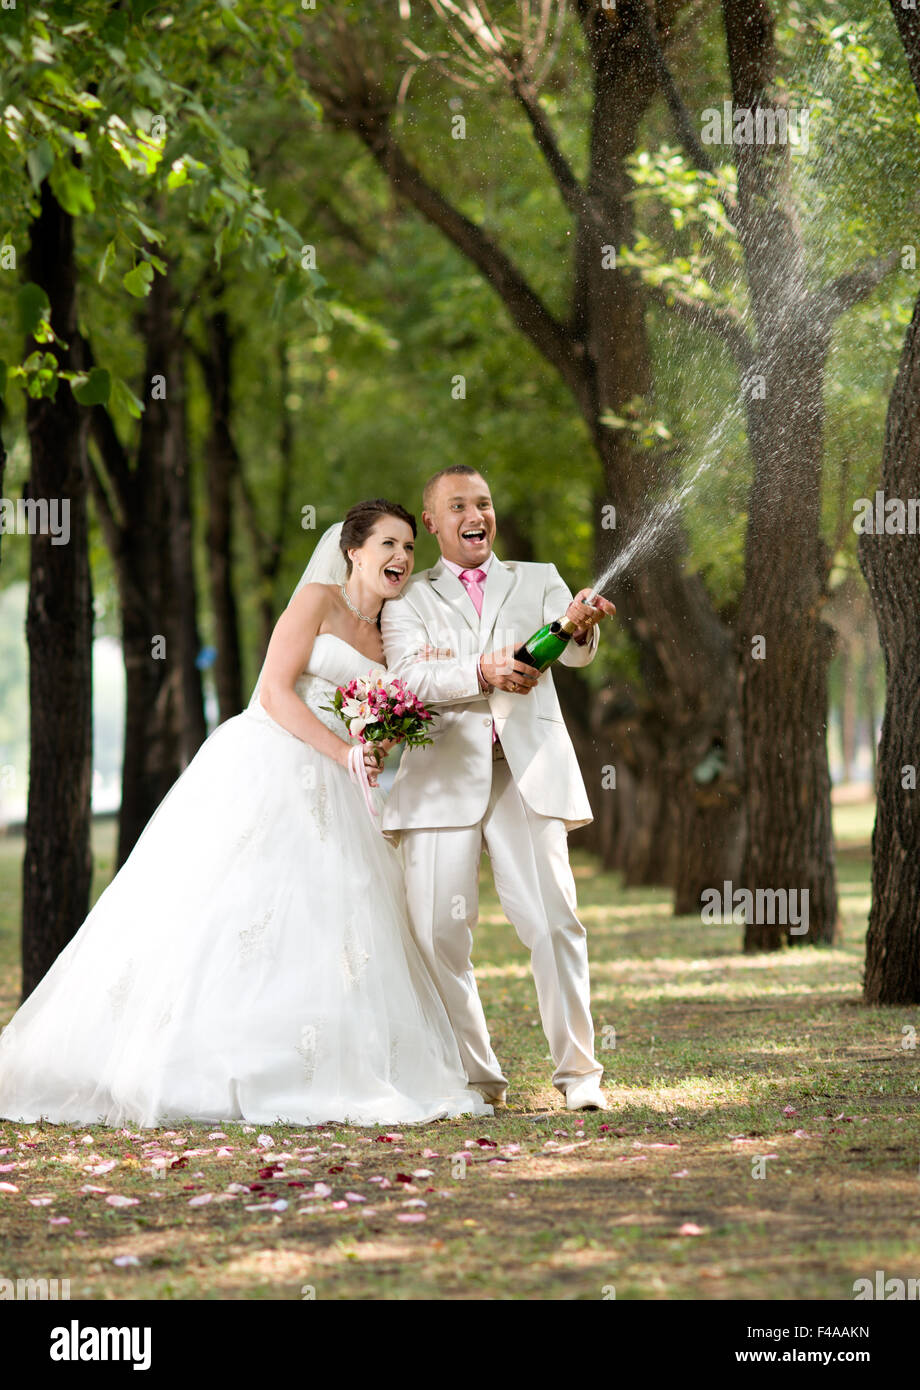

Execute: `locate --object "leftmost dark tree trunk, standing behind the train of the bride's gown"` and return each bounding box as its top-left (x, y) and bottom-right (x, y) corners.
top-left (22, 179), bottom-right (93, 998)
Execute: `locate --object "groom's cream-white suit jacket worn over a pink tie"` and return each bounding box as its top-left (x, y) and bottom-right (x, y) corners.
top-left (381, 555), bottom-right (598, 842)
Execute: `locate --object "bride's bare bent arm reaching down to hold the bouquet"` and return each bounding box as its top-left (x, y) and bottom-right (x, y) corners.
top-left (258, 584), bottom-right (369, 766)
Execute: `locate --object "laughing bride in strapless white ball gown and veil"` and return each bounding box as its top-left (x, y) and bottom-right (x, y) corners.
top-left (0, 499), bottom-right (492, 1127)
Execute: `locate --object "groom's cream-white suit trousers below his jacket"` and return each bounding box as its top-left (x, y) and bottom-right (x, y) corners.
top-left (402, 760), bottom-right (603, 1094)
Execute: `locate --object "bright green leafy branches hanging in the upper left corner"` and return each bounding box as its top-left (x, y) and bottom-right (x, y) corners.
top-left (0, 0), bottom-right (332, 422)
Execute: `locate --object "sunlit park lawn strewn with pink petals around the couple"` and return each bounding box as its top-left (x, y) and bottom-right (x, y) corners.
top-left (0, 808), bottom-right (920, 1300)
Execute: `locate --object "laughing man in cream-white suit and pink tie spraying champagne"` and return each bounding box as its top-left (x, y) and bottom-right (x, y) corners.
top-left (381, 464), bottom-right (614, 1111)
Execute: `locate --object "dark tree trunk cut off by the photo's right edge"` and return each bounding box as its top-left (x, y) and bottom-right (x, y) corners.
top-left (859, 0), bottom-right (920, 1004)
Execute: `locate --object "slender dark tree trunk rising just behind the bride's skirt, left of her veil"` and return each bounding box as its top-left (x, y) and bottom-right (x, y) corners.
top-left (204, 309), bottom-right (243, 723)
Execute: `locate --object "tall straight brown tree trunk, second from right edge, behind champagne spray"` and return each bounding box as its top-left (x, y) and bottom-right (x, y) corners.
top-left (723, 0), bottom-right (838, 951)
